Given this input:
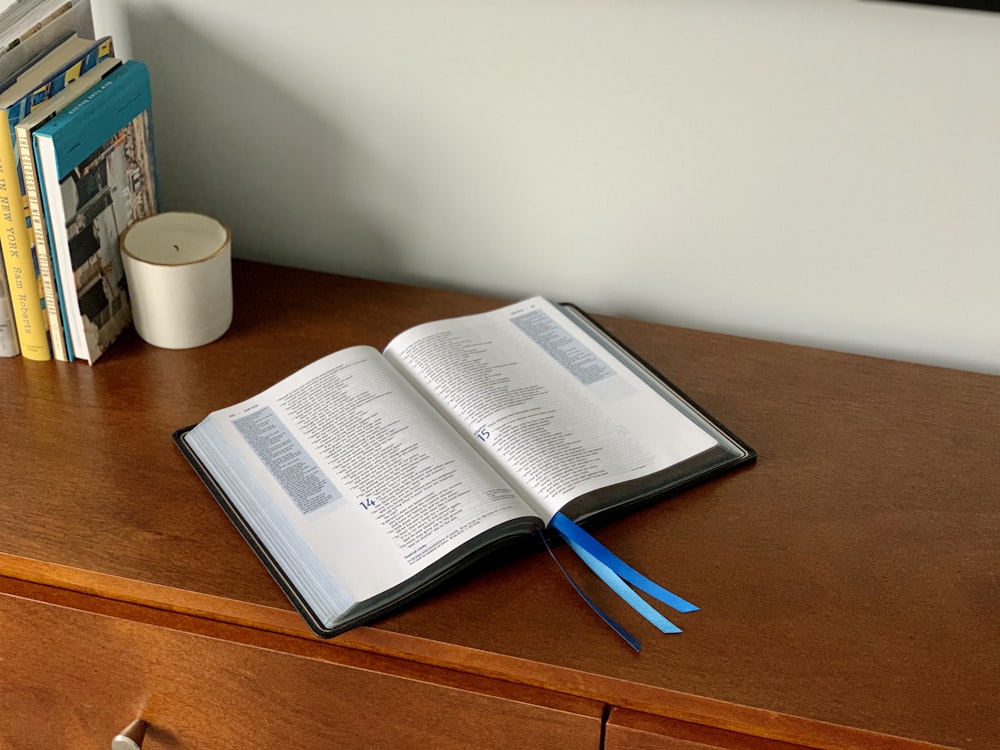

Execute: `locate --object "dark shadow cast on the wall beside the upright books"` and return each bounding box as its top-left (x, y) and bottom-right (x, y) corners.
top-left (125, 4), bottom-right (400, 275)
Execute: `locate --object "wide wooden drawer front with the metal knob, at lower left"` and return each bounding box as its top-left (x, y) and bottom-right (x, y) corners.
top-left (0, 594), bottom-right (601, 750)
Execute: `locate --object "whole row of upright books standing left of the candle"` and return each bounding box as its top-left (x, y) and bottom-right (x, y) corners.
top-left (0, 0), bottom-right (159, 364)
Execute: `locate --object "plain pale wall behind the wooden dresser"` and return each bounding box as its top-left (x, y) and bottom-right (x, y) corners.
top-left (93, 0), bottom-right (1000, 373)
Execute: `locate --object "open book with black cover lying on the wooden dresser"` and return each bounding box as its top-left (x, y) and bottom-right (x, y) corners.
top-left (174, 297), bottom-right (755, 637)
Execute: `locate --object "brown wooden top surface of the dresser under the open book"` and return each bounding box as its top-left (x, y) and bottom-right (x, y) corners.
top-left (0, 261), bottom-right (1000, 748)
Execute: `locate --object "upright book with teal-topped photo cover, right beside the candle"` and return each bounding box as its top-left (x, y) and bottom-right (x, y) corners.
top-left (34, 60), bottom-right (158, 364)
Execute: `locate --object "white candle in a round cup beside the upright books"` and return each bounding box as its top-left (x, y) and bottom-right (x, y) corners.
top-left (121, 212), bottom-right (233, 349)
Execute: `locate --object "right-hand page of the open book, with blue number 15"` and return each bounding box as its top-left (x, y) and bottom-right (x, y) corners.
top-left (385, 297), bottom-right (716, 523)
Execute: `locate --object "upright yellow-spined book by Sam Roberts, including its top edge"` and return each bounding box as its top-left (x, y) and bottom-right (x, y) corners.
top-left (0, 36), bottom-right (112, 360)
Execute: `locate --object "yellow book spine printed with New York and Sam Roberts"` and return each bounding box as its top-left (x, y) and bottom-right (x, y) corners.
top-left (0, 110), bottom-right (52, 361)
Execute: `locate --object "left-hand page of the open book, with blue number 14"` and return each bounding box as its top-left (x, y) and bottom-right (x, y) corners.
top-left (193, 347), bottom-right (531, 619)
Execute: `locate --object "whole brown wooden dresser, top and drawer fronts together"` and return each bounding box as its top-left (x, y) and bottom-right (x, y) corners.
top-left (0, 262), bottom-right (1000, 750)
